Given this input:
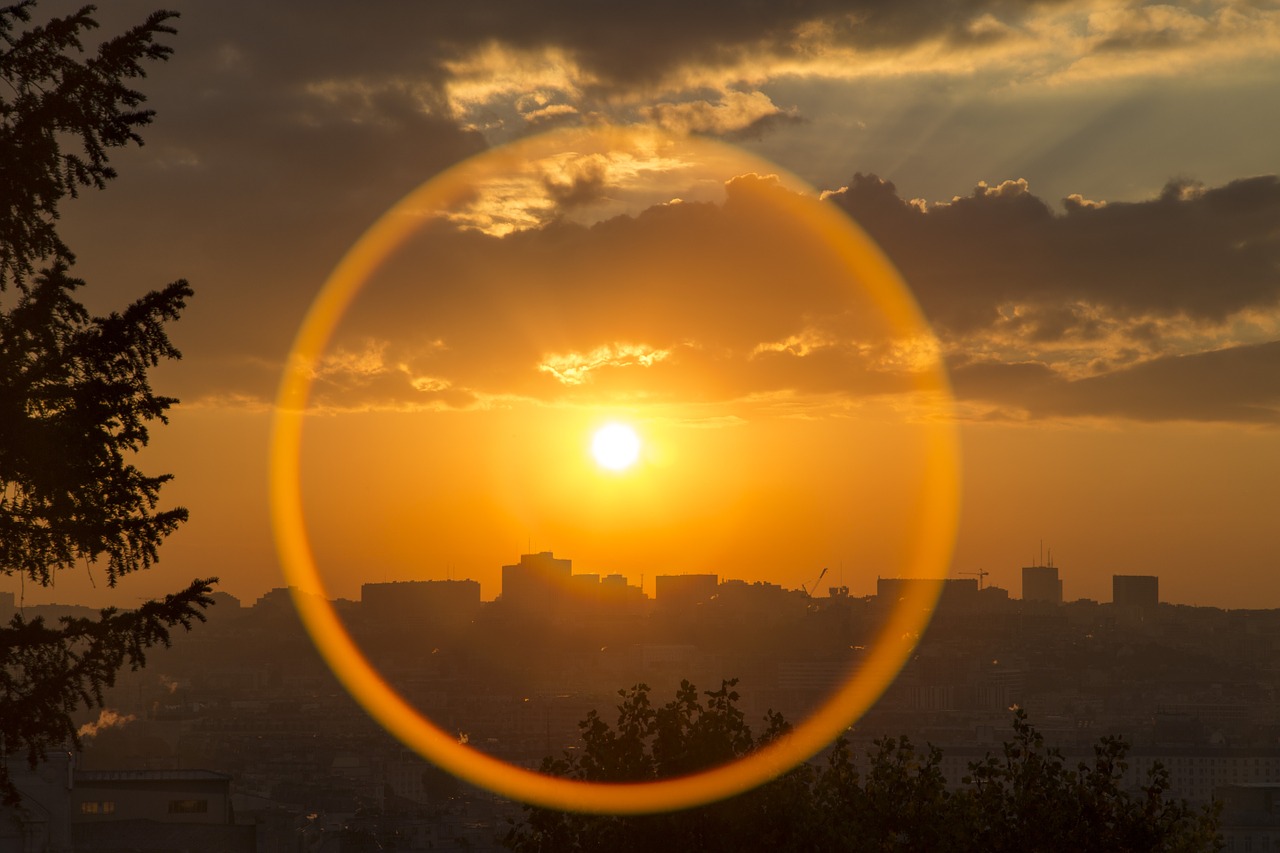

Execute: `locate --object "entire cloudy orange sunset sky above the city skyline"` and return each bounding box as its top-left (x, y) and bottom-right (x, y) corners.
top-left (12, 0), bottom-right (1280, 607)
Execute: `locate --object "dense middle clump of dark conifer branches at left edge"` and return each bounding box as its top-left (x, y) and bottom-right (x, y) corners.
top-left (0, 263), bottom-right (191, 585)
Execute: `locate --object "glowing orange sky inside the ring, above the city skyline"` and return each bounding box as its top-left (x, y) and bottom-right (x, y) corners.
top-left (264, 131), bottom-right (957, 594)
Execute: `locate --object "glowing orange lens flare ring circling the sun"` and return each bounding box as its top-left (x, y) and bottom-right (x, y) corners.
top-left (270, 128), bottom-right (959, 815)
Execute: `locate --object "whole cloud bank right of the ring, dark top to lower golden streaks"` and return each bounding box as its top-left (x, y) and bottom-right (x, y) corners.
top-left (826, 175), bottom-right (1280, 423)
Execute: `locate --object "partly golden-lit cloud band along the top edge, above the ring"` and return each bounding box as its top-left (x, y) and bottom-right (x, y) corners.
top-left (90, 0), bottom-right (1280, 186)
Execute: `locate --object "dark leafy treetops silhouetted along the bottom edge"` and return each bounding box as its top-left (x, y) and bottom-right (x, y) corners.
top-left (504, 681), bottom-right (1221, 853)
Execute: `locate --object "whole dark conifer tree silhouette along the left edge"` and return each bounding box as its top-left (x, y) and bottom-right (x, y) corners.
top-left (0, 0), bottom-right (216, 802)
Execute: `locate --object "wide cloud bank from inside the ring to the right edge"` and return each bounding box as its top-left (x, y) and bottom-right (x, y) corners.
top-left (162, 152), bottom-right (1280, 423)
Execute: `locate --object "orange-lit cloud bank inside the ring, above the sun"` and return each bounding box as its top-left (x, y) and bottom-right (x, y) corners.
top-left (267, 166), bottom-right (941, 411)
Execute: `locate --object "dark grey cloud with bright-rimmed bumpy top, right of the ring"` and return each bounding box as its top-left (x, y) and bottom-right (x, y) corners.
top-left (828, 175), bottom-right (1280, 332)
